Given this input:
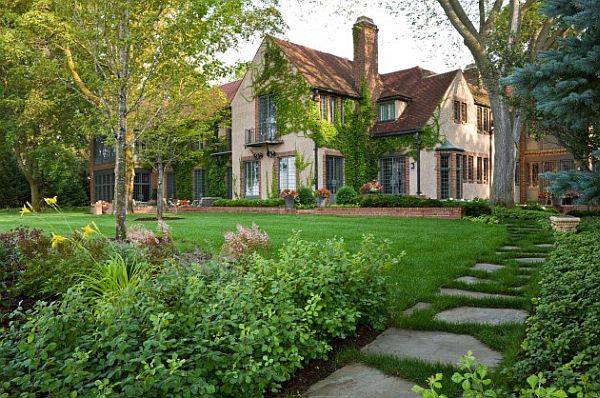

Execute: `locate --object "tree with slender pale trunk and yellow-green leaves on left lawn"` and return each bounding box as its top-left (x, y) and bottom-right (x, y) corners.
top-left (23, 0), bottom-right (281, 240)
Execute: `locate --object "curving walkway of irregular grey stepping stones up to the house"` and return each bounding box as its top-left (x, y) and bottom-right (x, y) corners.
top-left (303, 225), bottom-right (553, 398)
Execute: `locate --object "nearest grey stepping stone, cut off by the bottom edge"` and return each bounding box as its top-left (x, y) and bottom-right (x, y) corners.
top-left (302, 364), bottom-right (420, 398)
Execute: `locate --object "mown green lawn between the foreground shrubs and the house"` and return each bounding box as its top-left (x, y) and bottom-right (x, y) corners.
top-left (0, 211), bottom-right (507, 312)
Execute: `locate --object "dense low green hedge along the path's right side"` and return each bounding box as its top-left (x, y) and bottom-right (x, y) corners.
top-left (516, 231), bottom-right (600, 396)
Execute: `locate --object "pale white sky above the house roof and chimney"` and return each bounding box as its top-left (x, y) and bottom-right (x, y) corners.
top-left (224, 0), bottom-right (473, 73)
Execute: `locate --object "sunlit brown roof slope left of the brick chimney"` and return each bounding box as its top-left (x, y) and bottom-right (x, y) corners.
top-left (271, 37), bottom-right (359, 97)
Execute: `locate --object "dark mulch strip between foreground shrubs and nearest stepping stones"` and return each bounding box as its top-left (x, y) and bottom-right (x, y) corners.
top-left (265, 325), bottom-right (381, 398)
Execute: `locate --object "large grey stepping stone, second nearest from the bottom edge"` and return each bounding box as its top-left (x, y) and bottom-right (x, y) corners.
top-left (362, 328), bottom-right (502, 368)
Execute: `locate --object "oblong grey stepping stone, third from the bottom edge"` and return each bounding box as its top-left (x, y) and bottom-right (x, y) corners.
top-left (433, 307), bottom-right (527, 325)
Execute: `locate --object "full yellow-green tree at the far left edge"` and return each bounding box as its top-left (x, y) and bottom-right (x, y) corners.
top-left (0, 1), bottom-right (93, 210)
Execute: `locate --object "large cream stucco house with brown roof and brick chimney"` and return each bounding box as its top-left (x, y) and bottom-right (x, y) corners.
top-left (91, 17), bottom-right (572, 202)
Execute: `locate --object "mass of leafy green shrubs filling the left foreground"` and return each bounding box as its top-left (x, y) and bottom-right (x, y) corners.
top-left (0, 236), bottom-right (397, 397)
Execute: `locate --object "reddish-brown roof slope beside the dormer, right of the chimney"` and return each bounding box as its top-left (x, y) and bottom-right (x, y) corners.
top-left (371, 69), bottom-right (459, 137)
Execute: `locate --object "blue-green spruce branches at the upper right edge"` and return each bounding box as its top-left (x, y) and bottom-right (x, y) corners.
top-left (506, 0), bottom-right (600, 166)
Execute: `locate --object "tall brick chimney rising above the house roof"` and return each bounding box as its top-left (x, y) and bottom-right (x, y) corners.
top-left (352, 17), bottom-right (381, 99)
